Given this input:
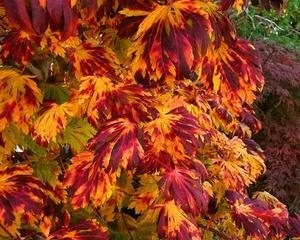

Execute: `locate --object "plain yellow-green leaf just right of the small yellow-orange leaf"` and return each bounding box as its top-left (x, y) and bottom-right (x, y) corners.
top-left (59, 119), bottom-right (96, 153)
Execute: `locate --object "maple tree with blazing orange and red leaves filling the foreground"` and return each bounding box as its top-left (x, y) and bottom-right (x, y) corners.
top-left (0, 0), bottom-right (300, 239)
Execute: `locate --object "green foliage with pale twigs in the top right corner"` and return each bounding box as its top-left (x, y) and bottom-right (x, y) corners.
top-left (234, 0), bottom-right (300, 50)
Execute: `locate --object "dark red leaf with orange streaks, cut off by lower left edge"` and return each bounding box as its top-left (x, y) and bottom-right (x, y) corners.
top-left (0, 164), bottom-right (48, 234)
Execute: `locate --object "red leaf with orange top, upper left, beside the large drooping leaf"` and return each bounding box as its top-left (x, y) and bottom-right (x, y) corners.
top-left (69, 41), bottom-right (117, 79)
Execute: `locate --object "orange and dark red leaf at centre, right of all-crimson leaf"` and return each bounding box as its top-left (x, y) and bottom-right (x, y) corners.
top-left (141, 96), bottom-right (202, 171)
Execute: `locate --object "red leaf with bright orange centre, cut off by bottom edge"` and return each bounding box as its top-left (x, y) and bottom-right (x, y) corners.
top-left (157, 201), bottom-right (202, 240)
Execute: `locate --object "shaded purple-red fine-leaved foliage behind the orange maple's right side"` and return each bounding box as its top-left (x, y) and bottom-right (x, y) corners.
top-left (255, 39), bottom-right (300, 212)
